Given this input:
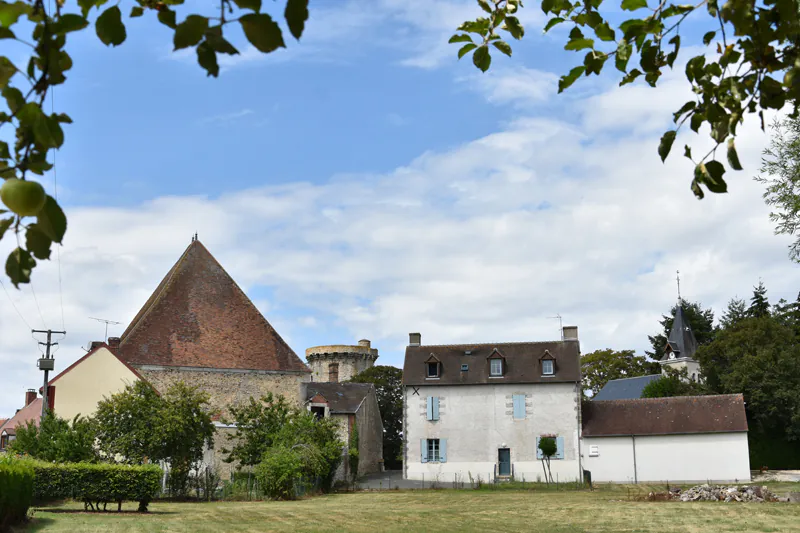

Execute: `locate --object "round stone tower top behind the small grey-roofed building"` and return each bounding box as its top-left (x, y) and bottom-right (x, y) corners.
top-left (306, 339), bottom-right (378, 382)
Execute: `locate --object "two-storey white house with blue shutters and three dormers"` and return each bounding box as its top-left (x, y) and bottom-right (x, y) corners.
top-left (403, 327), bottom-right (582, 482)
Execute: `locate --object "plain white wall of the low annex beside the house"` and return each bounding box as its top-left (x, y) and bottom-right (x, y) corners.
top-left (582, 432), bottom-right (750, 483)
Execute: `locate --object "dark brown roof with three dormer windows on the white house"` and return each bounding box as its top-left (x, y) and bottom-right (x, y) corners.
top-left (403, 340), bottom-right (581, 385)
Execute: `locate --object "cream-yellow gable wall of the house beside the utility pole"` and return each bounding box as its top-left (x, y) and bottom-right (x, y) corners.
top-left (49, 343), bottom-right (143, 420)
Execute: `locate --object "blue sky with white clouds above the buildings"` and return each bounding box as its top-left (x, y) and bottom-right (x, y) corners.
top-left (0, 0), bottom-right (800, 418)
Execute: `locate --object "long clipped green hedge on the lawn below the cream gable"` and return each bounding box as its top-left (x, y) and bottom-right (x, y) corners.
top-left (33, 461), bottom-right (162, 512)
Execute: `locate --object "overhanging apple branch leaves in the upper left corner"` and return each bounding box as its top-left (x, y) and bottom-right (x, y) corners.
top-left (0, 0), bottom-right (309, 287)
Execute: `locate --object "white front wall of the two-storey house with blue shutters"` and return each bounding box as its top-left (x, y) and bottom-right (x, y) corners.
top-left (404, 383), bottom-right (580, 482)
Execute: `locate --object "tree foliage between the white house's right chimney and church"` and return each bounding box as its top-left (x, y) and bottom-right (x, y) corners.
top-left (581, 348), bottom-right (661, 396)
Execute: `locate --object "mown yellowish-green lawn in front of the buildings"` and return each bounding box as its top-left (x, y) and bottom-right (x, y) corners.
top-left (17, 486), bottom-right (800, 533)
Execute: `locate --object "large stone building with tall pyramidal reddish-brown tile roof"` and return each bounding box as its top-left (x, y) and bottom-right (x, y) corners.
top-left (113, 239), bottom-right (311, 476)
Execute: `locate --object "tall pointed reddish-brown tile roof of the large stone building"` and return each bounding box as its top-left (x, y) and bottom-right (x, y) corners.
top-left (118, 240), bottom-right (310, 372)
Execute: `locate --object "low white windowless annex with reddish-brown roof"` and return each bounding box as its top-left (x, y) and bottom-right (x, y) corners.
top-left (582, 394), bottom-right (750, 483)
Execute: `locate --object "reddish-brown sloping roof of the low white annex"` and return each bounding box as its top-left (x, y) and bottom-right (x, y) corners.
top-left (582, 394), bottom-right (747, 437)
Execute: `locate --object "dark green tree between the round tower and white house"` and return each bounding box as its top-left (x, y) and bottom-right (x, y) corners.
top-left (350, 365), bottom-right (403, 470)
